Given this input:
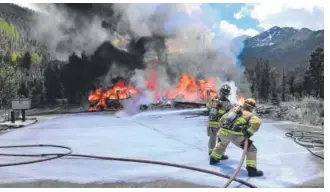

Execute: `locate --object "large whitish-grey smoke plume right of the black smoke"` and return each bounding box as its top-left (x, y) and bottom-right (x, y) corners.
top-left (109, 4), bottom-right (249, 99)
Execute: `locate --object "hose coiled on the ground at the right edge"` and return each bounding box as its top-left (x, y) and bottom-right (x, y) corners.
top-left (285, 130), bottom-right (324, 160)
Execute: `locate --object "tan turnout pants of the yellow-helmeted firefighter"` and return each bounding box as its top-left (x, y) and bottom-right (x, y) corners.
top-left (211, 129), bottom-right (257, 167)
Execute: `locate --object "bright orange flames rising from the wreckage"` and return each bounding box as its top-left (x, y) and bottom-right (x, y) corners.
top-left (88, 66), bottom-right (216, 111)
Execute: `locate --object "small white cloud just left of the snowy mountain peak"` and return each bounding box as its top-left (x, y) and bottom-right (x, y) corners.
top-left (220, 20), bottom-right (259, 38)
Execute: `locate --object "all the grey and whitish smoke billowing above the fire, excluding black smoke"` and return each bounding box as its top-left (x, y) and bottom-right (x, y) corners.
top-left (31, 4), bottom-right (249, 102)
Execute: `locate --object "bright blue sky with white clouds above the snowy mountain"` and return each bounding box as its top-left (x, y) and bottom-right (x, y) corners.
top-left (161, 1), bottom-right (324, 37)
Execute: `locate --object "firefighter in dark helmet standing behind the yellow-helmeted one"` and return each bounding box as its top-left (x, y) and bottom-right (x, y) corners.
top-left (207, 85), bottom-right (232, 155)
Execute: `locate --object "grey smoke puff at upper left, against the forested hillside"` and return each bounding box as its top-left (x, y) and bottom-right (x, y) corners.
top-left (32, 4), bottom-right (110, 60)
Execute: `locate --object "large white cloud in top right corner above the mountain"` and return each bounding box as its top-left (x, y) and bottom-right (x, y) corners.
top-left (234, 2), bottom-right (324, 30)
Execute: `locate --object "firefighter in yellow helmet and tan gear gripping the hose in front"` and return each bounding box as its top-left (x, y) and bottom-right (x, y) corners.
top-left (210, 98), bottom-right (263, 177)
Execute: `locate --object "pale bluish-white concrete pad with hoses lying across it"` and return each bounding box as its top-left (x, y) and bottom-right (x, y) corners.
top-left (0, 111), bottom-right (324, 187)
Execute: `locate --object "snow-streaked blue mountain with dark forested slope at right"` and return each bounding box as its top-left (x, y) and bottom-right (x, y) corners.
top-left (236, 26), bottom-right (324, 102)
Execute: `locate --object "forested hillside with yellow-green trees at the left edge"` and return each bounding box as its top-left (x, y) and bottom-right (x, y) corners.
top-left (0, 4), bottom-right (49, 105)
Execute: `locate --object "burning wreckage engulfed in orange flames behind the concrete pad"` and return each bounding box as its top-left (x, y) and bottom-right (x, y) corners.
top-left (88, 73), bottom-right (217, 112)
